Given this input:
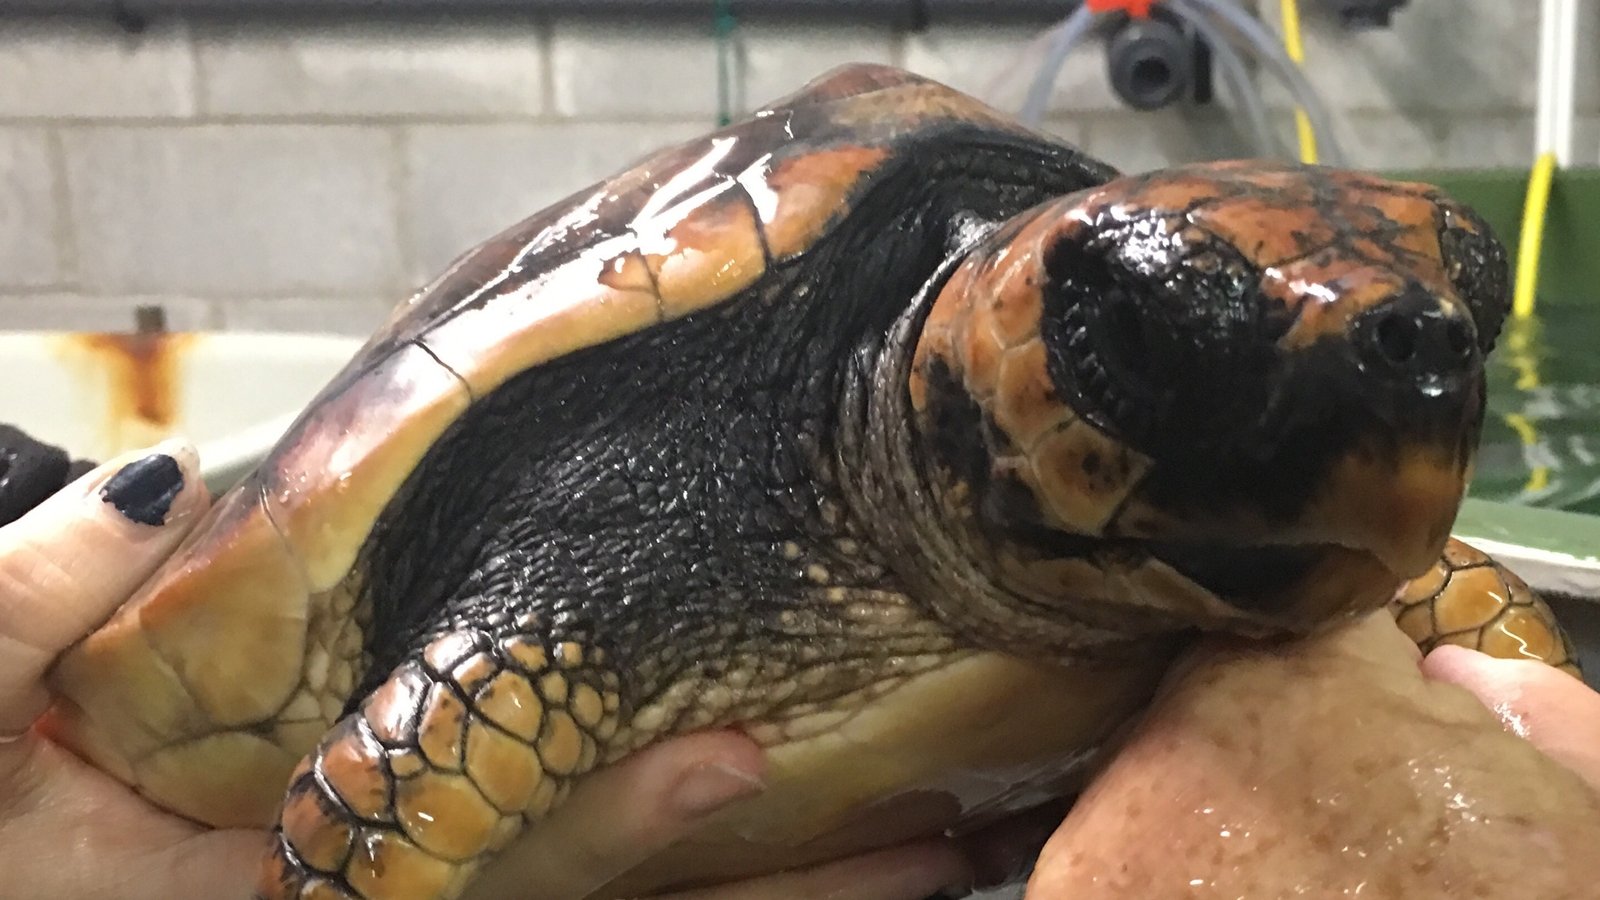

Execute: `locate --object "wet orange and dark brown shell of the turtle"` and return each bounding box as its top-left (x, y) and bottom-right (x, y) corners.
top-left (53, 67), bottom-right (1114, 890)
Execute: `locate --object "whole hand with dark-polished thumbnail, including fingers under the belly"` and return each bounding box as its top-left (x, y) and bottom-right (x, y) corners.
top-left (0, 432), bottom-right (998, 900)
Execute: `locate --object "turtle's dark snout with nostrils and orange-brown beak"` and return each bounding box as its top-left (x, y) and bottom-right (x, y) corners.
top-left (1222, 283), bottom-right (1485, 578)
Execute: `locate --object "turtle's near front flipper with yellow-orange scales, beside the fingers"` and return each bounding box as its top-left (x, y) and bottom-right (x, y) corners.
top-left (258, 631), bottom-right (621, 900)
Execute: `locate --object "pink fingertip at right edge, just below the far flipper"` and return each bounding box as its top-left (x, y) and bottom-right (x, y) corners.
top-left (1422, 644), bottom-right (1600, 790)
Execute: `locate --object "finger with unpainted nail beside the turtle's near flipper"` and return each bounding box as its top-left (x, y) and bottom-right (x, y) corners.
top-left (457, 730), bottom-right (765, 900)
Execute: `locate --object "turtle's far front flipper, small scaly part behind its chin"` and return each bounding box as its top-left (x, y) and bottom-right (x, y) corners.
top-left (1389, 538), bottom-right (1581, 677)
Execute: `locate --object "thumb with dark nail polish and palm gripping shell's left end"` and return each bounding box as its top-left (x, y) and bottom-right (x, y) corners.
top-left (0, 444), bottom-right (264, 900)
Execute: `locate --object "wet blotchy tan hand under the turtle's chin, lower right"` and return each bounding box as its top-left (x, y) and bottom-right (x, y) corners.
top-left (1027, 613), bottom-right (1600, 900)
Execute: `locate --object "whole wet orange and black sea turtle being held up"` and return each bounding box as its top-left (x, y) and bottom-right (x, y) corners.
top-left (34, 66), bottom-right (1565, 900)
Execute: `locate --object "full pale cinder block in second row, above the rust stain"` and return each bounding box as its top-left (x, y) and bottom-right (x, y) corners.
top-left (62, 125), bottom-right (403, 296)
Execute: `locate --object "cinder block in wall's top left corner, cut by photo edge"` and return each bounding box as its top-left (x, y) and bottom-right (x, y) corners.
top-left (0, 18), bottom-right (195, 119)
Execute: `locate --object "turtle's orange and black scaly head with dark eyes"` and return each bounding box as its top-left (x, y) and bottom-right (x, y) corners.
top-left (910, 162), bottom-right (1507, 629)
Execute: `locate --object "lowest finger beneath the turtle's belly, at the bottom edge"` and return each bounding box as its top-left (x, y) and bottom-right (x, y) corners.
top-left (661, 839), bottom-right (973, 900)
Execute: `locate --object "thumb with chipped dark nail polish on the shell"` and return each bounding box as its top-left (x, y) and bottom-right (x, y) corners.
top-left (0, 440), bottom-right (210, 737)
